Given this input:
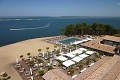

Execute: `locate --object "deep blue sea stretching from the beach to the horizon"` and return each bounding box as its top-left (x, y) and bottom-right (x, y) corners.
top-left (0, 16), bottom-right (120, 46)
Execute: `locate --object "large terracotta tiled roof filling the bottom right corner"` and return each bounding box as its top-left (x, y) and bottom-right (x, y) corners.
top-left (74, 55), bottom-right (120, 80)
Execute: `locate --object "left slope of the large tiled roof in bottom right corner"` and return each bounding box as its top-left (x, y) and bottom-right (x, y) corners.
top-left (85, 55), bottom-right (120, 80)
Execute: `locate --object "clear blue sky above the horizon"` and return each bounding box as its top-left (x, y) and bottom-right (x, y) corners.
top-left (0, 0), bottom-right (120, 17)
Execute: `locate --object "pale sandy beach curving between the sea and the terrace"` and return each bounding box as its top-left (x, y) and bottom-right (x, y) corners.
top-left (0, 37), bottom-right (54, 80)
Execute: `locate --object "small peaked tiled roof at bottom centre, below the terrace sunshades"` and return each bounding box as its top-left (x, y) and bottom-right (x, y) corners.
top-left (42, 69), bottom-right (72, 80)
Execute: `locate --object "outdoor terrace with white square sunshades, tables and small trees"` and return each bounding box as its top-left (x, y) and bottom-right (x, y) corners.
top-left (13, 44), bottom-right (102, 80)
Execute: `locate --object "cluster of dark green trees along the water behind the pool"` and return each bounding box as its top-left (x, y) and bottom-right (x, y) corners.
top-left (60, 23), bottom-right (120, 36)
